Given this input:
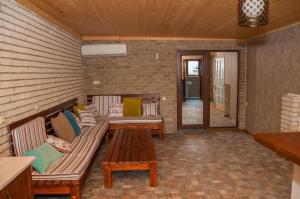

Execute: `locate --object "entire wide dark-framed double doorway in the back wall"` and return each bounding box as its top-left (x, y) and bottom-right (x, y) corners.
top-left (177, 50), bottom-right (239, 129)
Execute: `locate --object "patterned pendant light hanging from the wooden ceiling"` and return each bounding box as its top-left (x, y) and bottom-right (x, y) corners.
top-left (239, 0), bottom-right (269, 27)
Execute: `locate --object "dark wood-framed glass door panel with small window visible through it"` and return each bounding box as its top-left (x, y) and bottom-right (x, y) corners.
top-left (177, 50), bottom-right (209, 129)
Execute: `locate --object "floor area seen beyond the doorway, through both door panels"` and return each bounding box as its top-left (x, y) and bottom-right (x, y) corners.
top-left (182, 100), bottom-right (235, 127)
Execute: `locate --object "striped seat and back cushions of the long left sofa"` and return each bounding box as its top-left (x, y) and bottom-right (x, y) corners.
top-left (11, 117), bottom-right (109, 180)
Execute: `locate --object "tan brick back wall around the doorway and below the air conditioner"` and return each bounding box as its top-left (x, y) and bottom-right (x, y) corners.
top-left (83, 40), bottom-right (246, 133)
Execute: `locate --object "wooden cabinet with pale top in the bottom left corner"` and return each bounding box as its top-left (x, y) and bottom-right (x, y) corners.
top-left (0, 157), bottom-right (33, 199)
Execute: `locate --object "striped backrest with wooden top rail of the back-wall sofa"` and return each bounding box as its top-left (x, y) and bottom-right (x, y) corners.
top-left (87, 94), bottom-right (160, 116)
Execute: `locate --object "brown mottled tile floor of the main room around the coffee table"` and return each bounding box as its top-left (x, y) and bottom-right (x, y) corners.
top-left (77, 132), bottom-right (292, 199)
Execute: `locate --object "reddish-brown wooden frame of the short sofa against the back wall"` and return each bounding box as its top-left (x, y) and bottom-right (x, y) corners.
top-left (87, 94), bottom-right (164, 140)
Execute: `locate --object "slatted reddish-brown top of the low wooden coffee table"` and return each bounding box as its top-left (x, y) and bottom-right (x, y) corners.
top-left (103, 129), bottom-right (156, 164)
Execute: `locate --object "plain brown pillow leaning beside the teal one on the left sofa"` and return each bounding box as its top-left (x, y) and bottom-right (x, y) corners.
top-left (51, 112), bottom-right (76, 143)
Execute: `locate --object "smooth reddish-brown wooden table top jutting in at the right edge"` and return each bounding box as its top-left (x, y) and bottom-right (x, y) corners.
top-left (254, 132), bottom-right (300, 165)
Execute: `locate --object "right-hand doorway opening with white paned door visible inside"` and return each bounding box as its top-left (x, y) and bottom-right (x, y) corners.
top-left (210, 51), bottom-right (239, 127)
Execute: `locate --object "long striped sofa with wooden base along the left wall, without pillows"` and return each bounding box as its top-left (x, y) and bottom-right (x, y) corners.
top-left (10, 98), bottom-right (109, 199)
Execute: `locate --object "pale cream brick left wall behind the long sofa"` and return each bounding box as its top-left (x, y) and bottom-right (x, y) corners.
top-left (0, 0), bottom-right (84, 156)
